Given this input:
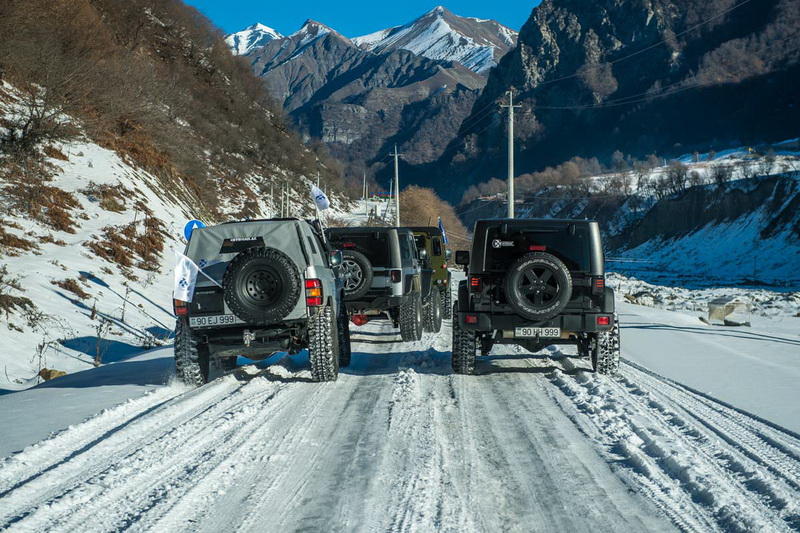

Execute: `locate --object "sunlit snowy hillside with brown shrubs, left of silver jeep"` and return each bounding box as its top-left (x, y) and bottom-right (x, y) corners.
top-left (0, 85), bottom-right (342, 391)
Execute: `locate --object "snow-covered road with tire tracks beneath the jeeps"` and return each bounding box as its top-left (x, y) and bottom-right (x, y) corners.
top-left (0, 310), bottom-right (800, 532)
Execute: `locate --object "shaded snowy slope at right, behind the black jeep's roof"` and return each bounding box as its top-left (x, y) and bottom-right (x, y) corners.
top-left (459, 145), bottom-right (800, 287)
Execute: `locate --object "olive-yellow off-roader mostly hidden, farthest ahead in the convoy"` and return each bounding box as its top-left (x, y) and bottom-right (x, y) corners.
top-left (408, 226), bottom-right (453, 331)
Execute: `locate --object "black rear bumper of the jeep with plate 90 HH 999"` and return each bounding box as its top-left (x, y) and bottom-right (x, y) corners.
top-left (455, 312), bottom-right (614, 334)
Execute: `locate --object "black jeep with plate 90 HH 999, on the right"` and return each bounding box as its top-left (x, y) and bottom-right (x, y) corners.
top-left (453, 219), bottom-right (619, 374)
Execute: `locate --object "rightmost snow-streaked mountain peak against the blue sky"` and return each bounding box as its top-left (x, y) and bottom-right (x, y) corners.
top-left (353, 6), bottom-right (517, 73)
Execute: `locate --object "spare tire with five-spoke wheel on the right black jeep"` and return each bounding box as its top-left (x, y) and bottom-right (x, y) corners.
top-left (505, 252), bottom-right (572, 320)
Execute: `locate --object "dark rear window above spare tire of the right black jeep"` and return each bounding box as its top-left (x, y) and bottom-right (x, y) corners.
top-left (486, 225), bottom-right (591, 272)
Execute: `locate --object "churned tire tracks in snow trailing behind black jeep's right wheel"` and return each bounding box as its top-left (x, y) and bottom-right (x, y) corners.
top-left (548, 357), bottom-right (797, 531)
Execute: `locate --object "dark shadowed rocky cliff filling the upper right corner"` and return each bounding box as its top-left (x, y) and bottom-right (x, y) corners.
top-left (418, 0), bottom-right (800, 203)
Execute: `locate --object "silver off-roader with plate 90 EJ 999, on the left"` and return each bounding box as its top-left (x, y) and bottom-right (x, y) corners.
top-left (173, 219), bottom-right (350, 385)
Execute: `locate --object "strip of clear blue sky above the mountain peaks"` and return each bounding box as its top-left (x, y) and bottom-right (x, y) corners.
top-left (185, 0), bottom-right (541, 37)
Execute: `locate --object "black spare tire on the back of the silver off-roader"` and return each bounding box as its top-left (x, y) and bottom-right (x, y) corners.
top-left (222, 248), bottom-right (301, 324)
